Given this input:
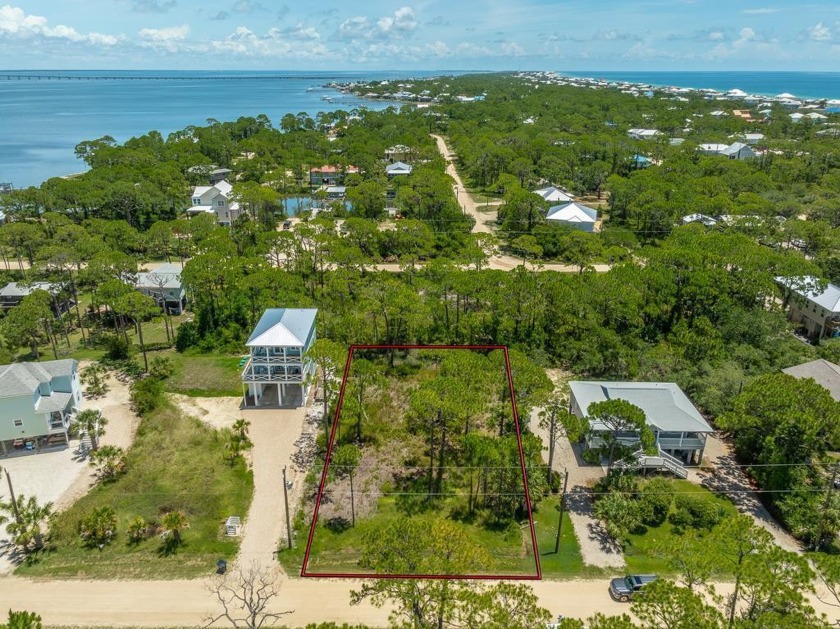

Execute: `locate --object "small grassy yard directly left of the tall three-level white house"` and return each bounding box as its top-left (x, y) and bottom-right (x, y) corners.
top-left (164, 352), bottom-right (242, 397)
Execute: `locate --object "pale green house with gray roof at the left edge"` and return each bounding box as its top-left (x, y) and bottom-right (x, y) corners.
top-left (0, 359), bottom-right (82, 456)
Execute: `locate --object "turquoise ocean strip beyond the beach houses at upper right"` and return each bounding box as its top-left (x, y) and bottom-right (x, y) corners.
top-left (558, 71), bottom-right (840, 98)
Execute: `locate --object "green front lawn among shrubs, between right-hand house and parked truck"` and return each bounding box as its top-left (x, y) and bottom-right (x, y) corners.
top-left (624, 480), bottom-right (738, 574)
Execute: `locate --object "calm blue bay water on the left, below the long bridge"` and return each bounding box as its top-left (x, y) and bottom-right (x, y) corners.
top-left (0, 70), bottom-right (446, 188)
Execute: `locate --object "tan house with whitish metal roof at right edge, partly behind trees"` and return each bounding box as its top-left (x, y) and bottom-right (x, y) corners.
top-left (776, 277), bottom-right (840, 339)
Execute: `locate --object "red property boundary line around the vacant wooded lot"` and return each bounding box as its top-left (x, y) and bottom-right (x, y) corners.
top-left (300, 345), bottom-right (542, 581)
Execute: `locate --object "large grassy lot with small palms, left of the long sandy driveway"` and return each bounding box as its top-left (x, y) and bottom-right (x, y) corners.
top-left (18, 403), bottom-right (253, 579)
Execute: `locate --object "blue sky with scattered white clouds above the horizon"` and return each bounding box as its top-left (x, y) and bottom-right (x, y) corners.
top-left (0, 0), bottom-right (840, 71)
